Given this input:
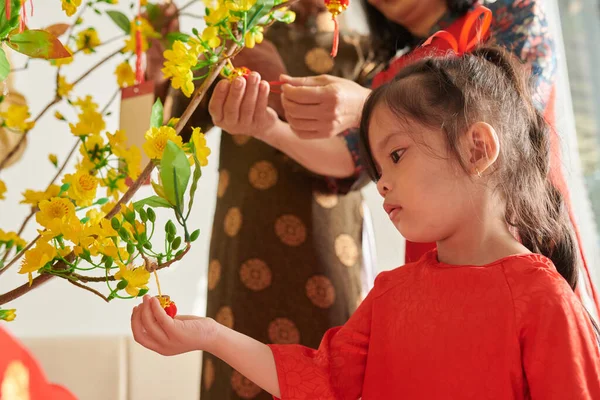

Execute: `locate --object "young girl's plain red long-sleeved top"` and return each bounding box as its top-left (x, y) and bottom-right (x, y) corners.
top-left (269, 250), bottom-right (600, 400)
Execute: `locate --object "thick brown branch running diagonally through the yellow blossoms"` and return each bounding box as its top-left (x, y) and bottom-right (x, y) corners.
top-left (0, 43), bottom-right (237, 305)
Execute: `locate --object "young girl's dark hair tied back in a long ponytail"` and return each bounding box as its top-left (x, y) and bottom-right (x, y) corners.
top-left (360, 47), bottom-right (578, 289)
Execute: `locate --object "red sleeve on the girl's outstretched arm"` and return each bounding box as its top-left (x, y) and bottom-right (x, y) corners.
top-left (269, 280), bottom-right (374, 400)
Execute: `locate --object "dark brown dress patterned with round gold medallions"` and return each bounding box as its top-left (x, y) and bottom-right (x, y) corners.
top-left (174, 15), bottom-right (375, 400)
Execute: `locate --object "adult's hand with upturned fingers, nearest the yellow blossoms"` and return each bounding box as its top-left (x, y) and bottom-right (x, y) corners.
top-left (208, 72), bottom-right (279, 140)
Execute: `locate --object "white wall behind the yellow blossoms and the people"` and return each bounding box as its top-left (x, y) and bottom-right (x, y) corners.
top-left (0, 1), bottom-right (403, 337)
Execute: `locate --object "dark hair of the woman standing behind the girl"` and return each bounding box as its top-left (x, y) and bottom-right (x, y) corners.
top-left (363, 0), bottom-right (476, 63)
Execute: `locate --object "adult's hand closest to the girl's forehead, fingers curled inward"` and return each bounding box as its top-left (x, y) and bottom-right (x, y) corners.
top-left (281, 75), bottom-right (371, 139)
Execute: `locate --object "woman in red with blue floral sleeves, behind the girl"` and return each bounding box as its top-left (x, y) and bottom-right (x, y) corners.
top-left (212, 0), bottom-right (598, 318)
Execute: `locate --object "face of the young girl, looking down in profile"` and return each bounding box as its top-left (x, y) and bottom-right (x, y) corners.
top-left (369, 104), bottom-right (480, 242)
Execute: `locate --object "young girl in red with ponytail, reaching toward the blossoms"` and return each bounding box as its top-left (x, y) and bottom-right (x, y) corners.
top-left (132, 48), bottom-right (600, 400)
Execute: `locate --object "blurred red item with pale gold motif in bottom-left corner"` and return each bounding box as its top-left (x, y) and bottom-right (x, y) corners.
top-left (0, 328), bottom-right (76, 400)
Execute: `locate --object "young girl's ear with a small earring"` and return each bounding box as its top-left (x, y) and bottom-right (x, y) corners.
top-left (463, 122), bottom-right (500, 175)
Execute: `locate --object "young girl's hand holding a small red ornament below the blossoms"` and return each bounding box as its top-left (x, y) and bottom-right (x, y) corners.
top-left (131, 296), bottom-right (218, 356)
